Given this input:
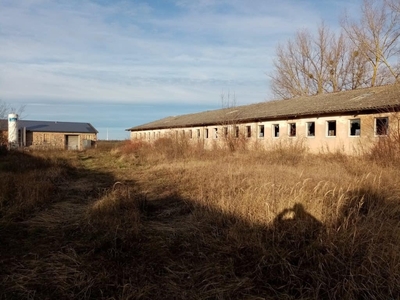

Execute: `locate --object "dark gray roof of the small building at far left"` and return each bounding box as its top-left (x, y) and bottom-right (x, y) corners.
top-left (0, 120), bottom-right (98, 133)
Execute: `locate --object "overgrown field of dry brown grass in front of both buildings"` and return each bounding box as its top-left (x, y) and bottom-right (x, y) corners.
top-left (0, 140), bottom-right (400, 299)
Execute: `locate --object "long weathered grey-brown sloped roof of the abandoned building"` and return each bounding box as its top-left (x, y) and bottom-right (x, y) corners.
top-left (127, 84), bottom-right (400, 131)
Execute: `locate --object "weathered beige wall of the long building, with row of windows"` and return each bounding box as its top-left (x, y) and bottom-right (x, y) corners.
top-left (130, 113), bottom-right (398, 154)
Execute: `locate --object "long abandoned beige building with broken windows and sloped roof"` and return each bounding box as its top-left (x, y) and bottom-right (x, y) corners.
top-left (127, 84), bottom-right (400, 154)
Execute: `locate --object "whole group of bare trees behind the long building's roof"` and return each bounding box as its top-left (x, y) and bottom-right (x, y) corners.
top-left (270, 0), bottom-right (400, 99)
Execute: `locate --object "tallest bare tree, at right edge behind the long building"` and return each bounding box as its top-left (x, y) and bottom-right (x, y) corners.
top-left (341, 0), bottom-right (400, 86)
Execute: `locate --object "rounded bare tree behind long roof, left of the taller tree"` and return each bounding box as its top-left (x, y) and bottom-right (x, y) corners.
top-left (271, 23), bottom-right (368, 99)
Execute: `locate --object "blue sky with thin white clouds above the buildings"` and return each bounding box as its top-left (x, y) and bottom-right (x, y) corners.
top-left (0, 0), bottom-right (359, 139)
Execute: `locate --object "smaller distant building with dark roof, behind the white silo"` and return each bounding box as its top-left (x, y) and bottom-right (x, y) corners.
top-left (0, 120), bottom-right (98, 150)
